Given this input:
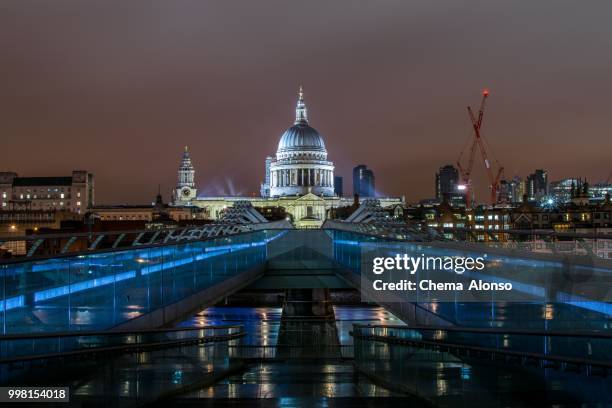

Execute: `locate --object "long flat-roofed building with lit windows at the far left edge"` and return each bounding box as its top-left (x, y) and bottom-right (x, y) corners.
top-left (0, 170), bottom-right (94, 214)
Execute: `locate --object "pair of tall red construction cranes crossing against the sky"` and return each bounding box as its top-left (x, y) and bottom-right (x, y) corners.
top-left (457, 89), bottom-right (504, 208)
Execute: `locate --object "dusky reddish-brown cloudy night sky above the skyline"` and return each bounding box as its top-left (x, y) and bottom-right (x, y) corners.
top-left (0, 0), bottom-right (612, 204)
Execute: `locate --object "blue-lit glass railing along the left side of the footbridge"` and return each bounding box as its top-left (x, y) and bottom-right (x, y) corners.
top-left (0, 230), bottom-right (284, 334)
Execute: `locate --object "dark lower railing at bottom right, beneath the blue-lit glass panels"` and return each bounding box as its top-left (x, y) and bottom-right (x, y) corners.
top-left (351, 324), bottom-right (612, 376)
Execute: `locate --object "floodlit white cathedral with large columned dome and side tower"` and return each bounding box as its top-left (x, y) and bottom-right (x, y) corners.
top-left (173, 87), bottom-right (404, 228)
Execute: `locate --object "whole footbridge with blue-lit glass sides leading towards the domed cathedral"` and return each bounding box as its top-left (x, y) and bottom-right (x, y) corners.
top-left (0, 204), bottom-right (612, 407)
